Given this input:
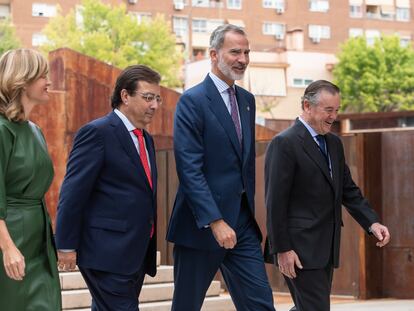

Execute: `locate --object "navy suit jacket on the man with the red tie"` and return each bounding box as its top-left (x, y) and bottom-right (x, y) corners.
top-left (56, 112), bottom-right (157, 275)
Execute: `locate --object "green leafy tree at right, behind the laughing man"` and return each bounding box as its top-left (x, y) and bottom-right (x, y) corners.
top-left (333, 36), bottom-right (414, 112)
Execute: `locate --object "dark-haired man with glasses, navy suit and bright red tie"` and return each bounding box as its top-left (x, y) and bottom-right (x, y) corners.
top-left (56, 65), bottom-right (162, 311)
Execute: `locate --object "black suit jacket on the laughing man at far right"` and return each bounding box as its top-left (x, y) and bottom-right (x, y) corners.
top-left (265, 120), bottom-right (378, 269)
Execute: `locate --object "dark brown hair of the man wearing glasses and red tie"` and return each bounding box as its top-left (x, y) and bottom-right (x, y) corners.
top-left (111, 65), bottom-right (161, 109)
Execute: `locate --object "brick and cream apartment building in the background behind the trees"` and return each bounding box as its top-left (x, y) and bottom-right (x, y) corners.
top-left (0, 0), bottom-right (414, 118)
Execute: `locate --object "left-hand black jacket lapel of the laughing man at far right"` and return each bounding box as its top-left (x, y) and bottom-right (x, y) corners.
top-left (296, 120), bottom-right (336, 192)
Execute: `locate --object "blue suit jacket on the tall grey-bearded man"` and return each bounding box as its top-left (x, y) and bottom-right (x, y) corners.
top-left (167, 76), bottom-right (255, 250)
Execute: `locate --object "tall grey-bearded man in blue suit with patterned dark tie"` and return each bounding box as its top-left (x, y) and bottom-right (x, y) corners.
top-left (167, 25), bottom-right (274, 311)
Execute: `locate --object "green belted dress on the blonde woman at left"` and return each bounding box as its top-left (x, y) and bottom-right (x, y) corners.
top-left (0, 115), bottom-right (61, 311)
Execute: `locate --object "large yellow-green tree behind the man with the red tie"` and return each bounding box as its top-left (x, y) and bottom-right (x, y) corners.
top-left (41, 0), bottom-right (183, 87)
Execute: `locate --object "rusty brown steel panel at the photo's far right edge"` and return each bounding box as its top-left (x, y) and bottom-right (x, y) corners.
top-left (382, 130), bottom-right (414, 299)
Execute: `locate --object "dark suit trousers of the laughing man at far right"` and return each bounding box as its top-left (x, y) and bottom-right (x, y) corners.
top-left (285, 264), bottom-right (333, 311)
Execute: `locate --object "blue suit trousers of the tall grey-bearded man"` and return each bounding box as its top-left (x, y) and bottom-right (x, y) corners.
top-left (171, 200), bottom-right (275, 311)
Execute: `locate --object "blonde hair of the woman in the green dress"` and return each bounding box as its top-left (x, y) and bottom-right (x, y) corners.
top-left (0, 49), bottom-right (49, 122)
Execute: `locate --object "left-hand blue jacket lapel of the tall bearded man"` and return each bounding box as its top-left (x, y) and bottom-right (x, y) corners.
top-left (204, 76), bottom-right (242, 160)
